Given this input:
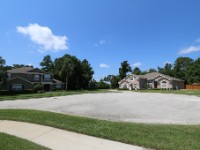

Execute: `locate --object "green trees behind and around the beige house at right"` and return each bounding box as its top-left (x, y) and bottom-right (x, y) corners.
top-left (100, 57), bottom-right (200, 88)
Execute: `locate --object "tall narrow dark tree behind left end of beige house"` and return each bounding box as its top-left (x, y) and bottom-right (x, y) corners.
top-left (119, 60), bottom-right (131, 79)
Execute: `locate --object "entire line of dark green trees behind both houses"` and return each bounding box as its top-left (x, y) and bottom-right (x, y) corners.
top-left (0, 54), bottom-right (200, 90)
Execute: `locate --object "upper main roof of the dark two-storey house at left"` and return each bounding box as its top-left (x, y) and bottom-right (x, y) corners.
top-left (7, 67), bottom-right (45, 73)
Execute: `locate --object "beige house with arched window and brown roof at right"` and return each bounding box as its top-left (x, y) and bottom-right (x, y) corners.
top-left (119, 72), bottom-right (185, 90)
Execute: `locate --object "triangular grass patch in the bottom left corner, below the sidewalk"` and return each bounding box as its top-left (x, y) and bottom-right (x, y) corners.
top-left (0, 133), bottom-right (48, 150)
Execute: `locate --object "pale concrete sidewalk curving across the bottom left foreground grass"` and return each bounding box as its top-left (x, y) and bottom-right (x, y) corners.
top-left (0, 120), bottom-right (145, 150)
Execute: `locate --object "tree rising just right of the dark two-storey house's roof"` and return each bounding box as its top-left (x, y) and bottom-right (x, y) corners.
top-left (40, 55), bottom-right (54, 73)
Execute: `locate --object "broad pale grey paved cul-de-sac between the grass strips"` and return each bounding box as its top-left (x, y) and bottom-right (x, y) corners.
top-left (0, 91), bottom-right (200, 124)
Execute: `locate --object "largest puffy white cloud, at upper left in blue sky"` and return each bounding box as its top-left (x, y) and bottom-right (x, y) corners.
top-left (17, 24), bottom-right (68, 52)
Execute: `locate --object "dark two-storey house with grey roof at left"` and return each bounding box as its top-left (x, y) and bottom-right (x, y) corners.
top-left (0, 67), bottom-right (64, 91)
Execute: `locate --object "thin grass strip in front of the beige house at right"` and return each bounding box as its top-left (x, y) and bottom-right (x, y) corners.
top-left (133, 90), bottom-right (200, 96)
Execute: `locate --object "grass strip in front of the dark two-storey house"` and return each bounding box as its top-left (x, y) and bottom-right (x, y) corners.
top-left (0, 90), bottom-right (111, 101)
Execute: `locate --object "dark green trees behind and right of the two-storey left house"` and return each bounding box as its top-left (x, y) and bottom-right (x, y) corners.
top-left (0, 54), bottom-right (94, 90)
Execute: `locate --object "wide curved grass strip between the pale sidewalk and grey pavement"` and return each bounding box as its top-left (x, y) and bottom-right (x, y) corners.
top-left (0, 109), bottom-right (200, 150)
